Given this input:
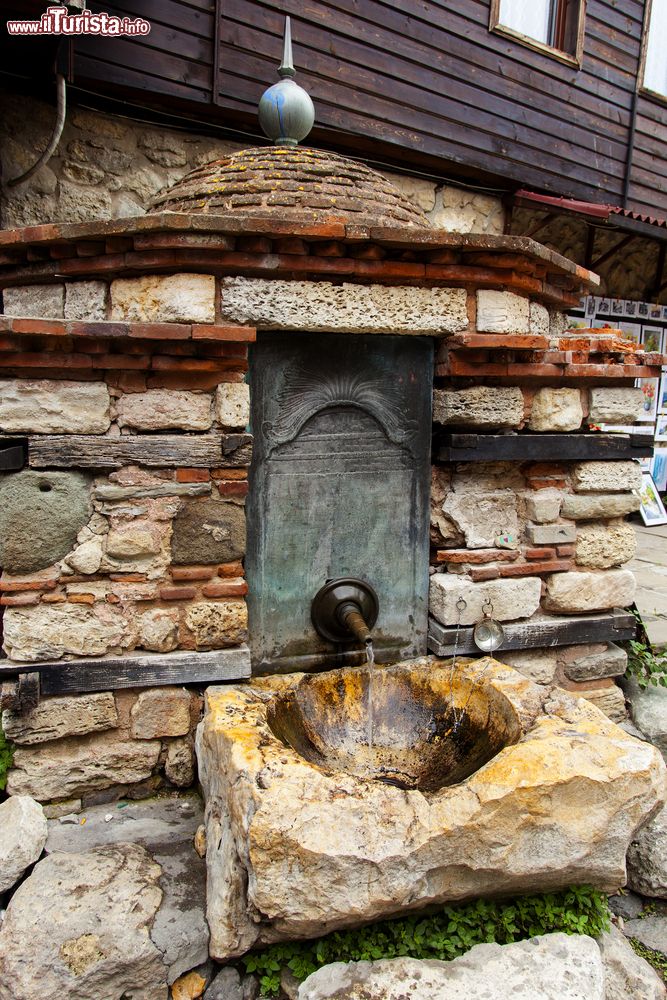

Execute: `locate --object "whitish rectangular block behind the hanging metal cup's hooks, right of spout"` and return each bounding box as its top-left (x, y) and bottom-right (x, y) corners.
top-left (429, 573), bottom-right (544, 625)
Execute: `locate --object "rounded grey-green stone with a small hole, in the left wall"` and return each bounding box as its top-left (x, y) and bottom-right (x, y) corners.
top-left (0, 469), bottom-right (92, 574)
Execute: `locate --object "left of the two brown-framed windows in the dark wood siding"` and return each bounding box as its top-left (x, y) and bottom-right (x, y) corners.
top-left (490, 0), bottom-right (588, 63)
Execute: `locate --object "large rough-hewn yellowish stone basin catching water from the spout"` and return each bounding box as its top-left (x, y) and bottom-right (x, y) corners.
top-left (197, 657), bottom-right (667, 961)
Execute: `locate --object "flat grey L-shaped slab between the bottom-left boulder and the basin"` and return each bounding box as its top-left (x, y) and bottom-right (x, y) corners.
top-left (46, 795), bottom-right (208, 984)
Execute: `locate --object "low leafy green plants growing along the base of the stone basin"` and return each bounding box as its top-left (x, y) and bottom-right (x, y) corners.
top-left (243, 886), bottom-right (609, 996)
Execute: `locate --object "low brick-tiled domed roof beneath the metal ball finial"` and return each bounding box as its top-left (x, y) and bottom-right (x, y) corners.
top-left (149, 146), bottom-right (430, 228)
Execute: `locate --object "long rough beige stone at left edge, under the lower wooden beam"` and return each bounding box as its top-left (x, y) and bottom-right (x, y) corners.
top-left (2, 691), bottom-right (118, 745)
